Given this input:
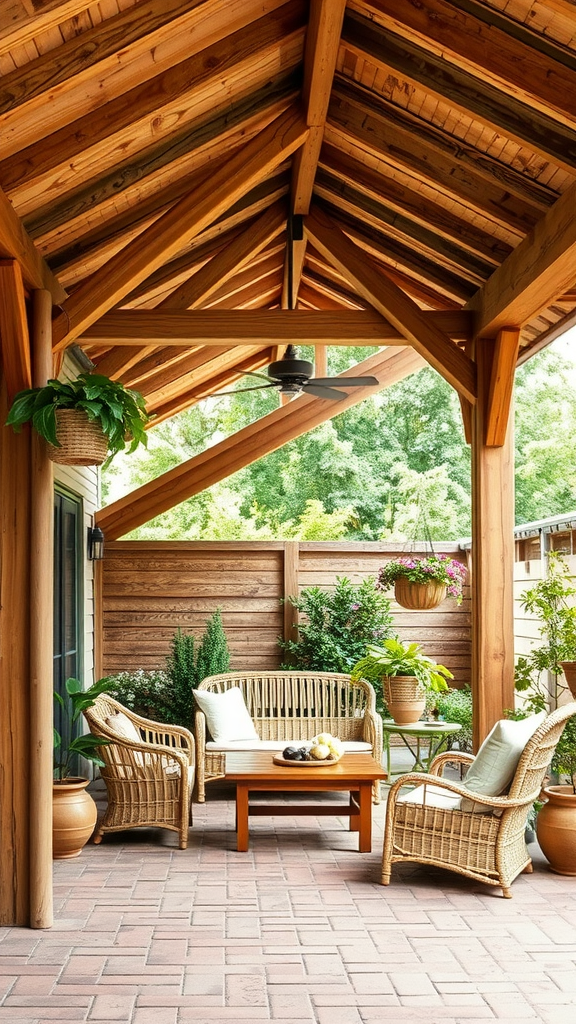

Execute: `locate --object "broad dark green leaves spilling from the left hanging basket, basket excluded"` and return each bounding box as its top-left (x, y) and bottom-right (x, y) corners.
top-left (6, 373), bottom-right (149, 458)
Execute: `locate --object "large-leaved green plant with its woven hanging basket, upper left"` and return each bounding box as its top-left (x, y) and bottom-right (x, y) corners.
top-left (6, 373), bottom-right (149, 466)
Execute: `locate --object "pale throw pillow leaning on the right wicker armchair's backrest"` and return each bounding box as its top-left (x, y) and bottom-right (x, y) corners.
top-left (461, 712), bottom-right (546, 811)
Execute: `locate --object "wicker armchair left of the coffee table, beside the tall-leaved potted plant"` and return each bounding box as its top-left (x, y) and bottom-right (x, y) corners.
top-left (84, 693), bottom-right (195, 850)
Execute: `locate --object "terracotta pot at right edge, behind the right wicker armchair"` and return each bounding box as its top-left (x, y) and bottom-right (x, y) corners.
top-left (536, 785), bottom-right (576, 874)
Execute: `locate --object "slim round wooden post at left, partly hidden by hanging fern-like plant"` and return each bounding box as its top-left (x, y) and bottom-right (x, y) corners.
top-left (30, 290), bottom-right (54, 928)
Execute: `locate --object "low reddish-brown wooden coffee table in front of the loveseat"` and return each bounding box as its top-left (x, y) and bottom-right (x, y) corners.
top-left (225, 751), bottom-right (387, 853)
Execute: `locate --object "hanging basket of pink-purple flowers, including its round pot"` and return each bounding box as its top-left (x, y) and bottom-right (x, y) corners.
top-left (378, 554), bottom-right (466, 608)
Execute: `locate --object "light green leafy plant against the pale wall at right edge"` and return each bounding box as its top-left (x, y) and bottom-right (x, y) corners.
top-left (515, 551), bottom-right (576, 712)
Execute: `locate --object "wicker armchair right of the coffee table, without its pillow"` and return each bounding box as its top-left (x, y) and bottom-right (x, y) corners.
top-left (381, 703), bottom-right (576, 898)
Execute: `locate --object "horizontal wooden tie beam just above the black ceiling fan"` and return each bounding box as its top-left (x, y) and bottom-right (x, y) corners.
top-left (81, 307), bottom-right (472, 347)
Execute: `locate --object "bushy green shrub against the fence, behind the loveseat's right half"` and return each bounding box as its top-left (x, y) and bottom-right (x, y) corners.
top-left (278, 577), bottom-right (392, 673)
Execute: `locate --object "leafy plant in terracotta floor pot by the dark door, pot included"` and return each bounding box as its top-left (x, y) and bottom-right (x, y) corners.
top-left (52, 679), bottom-right (110, 860)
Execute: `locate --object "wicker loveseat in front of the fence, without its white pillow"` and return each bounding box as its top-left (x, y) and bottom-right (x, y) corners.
top-left (194, 672), bottom-right (382, 803)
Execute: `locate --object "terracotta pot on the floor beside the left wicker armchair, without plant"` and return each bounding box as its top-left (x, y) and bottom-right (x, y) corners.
top-left (52, 778), bottom-right (97, 860)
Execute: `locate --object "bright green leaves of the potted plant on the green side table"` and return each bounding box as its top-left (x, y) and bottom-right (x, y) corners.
top-left (352, 637), bottom-right (453, 692)
